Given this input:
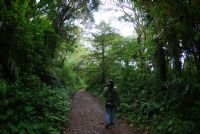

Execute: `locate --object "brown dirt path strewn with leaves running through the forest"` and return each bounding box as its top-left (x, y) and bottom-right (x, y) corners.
top-left (63, 90), bottom-right (138, 134)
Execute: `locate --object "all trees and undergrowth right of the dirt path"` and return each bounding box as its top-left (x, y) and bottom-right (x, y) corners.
top-left (83, 0), bottom-right (200, 134)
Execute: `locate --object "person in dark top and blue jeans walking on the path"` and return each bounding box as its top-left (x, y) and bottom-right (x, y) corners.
top-left (102, 80), bottom-right (119, 128)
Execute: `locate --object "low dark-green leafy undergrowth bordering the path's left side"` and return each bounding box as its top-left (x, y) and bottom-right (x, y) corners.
top-left (0, 76), bottom-right (75, 134)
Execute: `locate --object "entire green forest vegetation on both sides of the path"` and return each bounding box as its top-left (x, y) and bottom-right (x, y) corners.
top-left (0, 0), bottom-right (200, 134)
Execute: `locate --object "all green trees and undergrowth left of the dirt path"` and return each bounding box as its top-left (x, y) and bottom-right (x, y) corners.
top-left (0, 0), bottom-right (99, 134)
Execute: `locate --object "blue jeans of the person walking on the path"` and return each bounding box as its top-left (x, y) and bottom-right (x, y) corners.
top-left (105, 106), bottom-right (116, 124)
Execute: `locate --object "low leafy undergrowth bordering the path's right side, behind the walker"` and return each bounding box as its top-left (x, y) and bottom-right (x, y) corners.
top-left (88, 75), bottom-right (200, 134)
